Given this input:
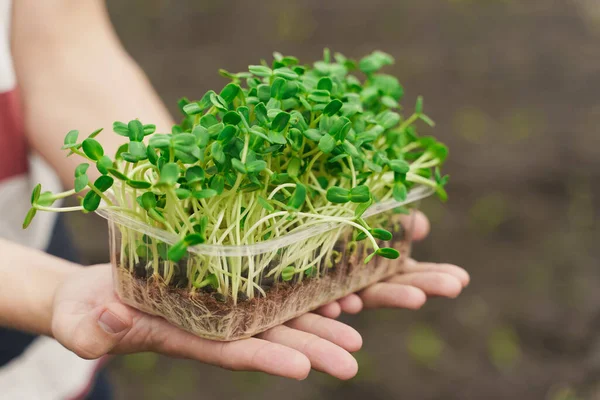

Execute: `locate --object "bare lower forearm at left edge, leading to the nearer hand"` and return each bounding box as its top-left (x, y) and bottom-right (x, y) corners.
top-left (0, 239), bottom-right (79, 336)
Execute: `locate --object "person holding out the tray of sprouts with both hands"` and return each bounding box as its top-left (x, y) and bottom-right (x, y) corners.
top-left (0, 0), bottom-right (469, 399)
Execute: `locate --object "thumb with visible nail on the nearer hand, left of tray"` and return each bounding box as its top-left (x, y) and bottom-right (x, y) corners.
top-left (52, 302), bottom-right (133, 359)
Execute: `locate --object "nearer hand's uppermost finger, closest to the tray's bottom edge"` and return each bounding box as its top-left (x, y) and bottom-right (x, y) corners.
top-left (286, 313), bottom-right (362, 351)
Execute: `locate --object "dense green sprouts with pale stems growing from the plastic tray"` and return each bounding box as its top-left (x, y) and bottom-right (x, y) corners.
top-left (23, 50), bottom-right (448, 300)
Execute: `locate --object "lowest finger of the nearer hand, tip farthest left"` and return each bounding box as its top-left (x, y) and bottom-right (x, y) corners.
top-left (146, 317), bottom-right (310, 380)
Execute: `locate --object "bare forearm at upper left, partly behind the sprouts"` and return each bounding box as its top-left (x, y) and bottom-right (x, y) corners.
top-left (13, 0), bottom-right (172, 185)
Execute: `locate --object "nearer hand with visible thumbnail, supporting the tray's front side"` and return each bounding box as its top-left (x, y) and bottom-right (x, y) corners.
top-left (51, 265), bottom-right (362, 379)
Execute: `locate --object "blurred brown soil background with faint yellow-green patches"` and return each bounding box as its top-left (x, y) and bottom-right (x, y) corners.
top-left (64, 0), bottom-right (600, 400)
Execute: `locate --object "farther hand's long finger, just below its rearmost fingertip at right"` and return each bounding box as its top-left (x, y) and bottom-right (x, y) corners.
top-left (387, 272), bottom-right (463, 298)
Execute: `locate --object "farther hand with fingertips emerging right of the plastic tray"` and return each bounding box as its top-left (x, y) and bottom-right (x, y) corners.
top-left (316, 212), bottom-right (470, 318)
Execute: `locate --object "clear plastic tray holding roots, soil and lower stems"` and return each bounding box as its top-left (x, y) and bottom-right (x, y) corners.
top-left (98, 187), bottom-right (432, 341)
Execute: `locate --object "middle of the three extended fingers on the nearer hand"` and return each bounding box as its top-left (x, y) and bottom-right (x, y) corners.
top-left (259, 325), bottom-right (358, 380)
